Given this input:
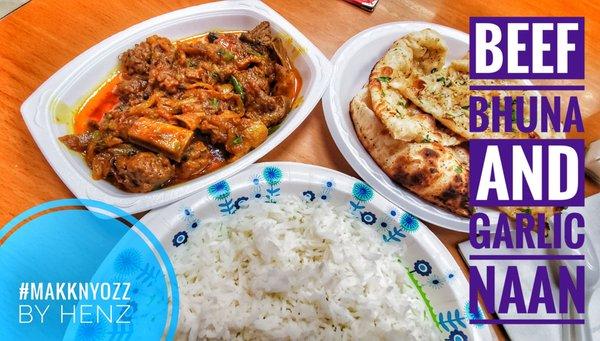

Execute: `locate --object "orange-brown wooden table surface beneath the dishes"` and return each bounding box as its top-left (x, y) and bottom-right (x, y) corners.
top-left (0, 0), bottom-right (600, 335)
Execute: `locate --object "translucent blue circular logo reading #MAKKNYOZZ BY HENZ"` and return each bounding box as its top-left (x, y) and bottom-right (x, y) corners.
top-left (0, 199), bottom-right (179, 340)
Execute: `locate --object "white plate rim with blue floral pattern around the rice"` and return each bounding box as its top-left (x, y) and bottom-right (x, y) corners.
top-left (141, 162), bottom-right (492, 341)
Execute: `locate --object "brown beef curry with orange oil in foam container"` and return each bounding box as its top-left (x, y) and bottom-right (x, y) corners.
top-left (60, 22), bottom-right (301, 192)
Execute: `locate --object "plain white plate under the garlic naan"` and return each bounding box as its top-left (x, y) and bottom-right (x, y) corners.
top-left (323, 22), bottom-right (469, 232)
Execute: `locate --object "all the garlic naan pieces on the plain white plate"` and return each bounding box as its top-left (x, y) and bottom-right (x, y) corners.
top-left (350, 29), bottom-right (564, 219)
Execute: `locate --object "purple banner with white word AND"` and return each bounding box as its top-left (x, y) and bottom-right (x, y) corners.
top-left (469, 139), bottom-right (585, 207)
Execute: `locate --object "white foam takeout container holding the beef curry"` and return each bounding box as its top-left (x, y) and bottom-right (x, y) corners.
top-left (21, 1), bottom-right (331, 213)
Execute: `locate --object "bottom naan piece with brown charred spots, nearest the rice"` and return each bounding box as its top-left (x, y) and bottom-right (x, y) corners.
top-left (350, 88), bottom-right (471, 217)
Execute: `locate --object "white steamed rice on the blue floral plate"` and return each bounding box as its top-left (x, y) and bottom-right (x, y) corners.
top-left (172, 196), bottom-right (440, 340)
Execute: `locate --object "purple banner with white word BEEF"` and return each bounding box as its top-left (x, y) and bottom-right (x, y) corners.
top-left (469, 17), bottom-right (585, 79)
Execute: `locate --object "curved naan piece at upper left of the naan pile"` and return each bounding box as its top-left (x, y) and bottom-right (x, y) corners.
top-left (368, 29), bottom-right (463, 146)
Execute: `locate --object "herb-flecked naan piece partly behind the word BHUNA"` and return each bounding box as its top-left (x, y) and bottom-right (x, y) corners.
top-left (390, 58), bottom-right (564, 139)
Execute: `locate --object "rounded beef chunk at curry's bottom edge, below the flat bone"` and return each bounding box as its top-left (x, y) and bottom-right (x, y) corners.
top-left (113, 152), bottom-right (175, 193)
